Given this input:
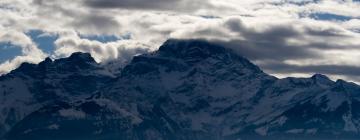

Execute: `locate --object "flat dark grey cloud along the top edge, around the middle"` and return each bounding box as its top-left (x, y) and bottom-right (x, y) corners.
top-left (84, 0), bottom-right (210, 11)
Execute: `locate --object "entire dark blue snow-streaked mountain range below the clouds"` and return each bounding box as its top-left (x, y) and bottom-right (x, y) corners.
top-left (0, 39), bottom-right (360, 140)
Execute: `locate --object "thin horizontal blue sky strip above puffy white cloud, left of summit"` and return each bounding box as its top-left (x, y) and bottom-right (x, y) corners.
top-left (79, 33), bottom-right (131, 43)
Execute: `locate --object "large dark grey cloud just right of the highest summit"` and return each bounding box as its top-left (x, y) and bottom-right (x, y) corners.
top-left (217, 19), bottom-right (321, 61)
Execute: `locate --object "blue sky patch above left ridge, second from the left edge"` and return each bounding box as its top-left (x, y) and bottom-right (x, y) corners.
top-left (26, 30), bottom-right (59, 54)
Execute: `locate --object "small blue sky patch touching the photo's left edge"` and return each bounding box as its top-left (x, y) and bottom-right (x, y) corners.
top-left (0, 42), bottom-right (22, 63)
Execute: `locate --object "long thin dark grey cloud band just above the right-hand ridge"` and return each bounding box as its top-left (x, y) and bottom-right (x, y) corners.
top-left (260, 62), bottom-right (360, 76)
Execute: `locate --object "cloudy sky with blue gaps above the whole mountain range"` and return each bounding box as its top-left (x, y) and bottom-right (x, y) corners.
top-left (0, 0), bottom-right (360, 83)
